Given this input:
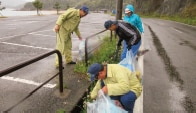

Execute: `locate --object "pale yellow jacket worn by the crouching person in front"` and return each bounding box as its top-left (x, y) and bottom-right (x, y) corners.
top-left (90, 64), bottom-right (142, 99)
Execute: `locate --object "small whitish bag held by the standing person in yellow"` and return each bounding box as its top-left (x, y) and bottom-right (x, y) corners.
top-left (78, 40), bottom-right (85, 61)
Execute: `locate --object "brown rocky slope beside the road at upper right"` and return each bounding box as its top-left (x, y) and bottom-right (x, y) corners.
top-left (136, 0), bottom-right (196, 18)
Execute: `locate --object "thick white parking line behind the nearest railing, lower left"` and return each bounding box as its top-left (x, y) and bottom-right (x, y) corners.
top-left (1, 76), bottom-right (56, 88)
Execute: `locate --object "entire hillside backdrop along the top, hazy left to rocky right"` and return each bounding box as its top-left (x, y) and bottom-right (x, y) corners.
top-left (23, 0), bottom-right (196, 17)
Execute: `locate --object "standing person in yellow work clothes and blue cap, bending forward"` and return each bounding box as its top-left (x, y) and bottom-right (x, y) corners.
top-left (54, 6), bottom-right (89, 67)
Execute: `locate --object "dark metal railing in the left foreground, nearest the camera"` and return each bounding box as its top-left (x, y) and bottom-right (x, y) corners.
top-left (0, 50), bottom-right (63, 113)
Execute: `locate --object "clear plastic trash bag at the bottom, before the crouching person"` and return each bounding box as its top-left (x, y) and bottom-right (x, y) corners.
top-left (87, 90), bottom-right (128, 113)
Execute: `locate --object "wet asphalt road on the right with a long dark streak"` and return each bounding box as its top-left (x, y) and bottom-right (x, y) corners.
top-left (143, 19), bottom-right (196, 113)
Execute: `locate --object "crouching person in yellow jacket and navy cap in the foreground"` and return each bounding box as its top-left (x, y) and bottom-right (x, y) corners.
top-left (88, 63), bottom-right (142, 113)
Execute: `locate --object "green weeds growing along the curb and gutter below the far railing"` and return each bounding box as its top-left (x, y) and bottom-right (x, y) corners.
top-left (74, 36), bottom-right (120, 113)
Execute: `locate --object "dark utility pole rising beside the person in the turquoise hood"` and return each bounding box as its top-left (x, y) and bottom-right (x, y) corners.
top-left (116, 0), bottom-right (123, 20)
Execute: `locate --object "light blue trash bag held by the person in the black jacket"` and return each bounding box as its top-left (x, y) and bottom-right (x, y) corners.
top-left (119, 50), bottom-right (135, 72)
